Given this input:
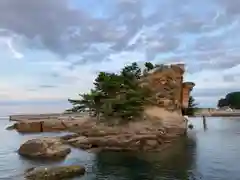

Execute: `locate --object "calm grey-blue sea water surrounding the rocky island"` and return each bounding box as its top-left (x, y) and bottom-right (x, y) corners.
top-left (0, 117), bottom-right (240, 180)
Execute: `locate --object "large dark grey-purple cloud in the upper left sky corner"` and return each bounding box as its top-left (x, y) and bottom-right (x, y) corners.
top-left (0, 0), bottom-right (139, 55)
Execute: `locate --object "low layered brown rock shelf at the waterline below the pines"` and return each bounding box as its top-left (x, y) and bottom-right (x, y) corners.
top-left (61, 110), bottom-right (186, 151)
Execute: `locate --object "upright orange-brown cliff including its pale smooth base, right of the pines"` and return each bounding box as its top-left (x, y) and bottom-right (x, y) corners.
top-left (141, 64), bottom-right (194, 129)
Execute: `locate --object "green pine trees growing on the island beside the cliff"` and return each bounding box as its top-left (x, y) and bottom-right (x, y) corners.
top-left (69, 63), bottom-right (153, 123)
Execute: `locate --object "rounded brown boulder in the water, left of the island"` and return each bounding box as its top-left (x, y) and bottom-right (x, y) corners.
top-left (18, 138), bottom-right (71, 160)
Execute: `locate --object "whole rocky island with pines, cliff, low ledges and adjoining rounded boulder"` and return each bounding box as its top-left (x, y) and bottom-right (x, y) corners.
top-left (9, 62), bottom-right (194, 179)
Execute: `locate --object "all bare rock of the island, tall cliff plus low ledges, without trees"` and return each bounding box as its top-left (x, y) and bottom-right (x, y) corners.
top-left (9, 64), bottom-right (194, 151)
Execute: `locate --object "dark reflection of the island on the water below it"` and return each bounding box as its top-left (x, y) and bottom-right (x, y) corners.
top-left (95, 138), bottom-right (196, 180)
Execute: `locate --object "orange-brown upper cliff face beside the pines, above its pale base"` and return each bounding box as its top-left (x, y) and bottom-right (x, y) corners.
top-left (141, 64), bottom-right (194, 112)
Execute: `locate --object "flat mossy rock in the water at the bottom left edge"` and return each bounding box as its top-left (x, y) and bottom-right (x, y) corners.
top-left (25, 166), bottom-right (85, 180)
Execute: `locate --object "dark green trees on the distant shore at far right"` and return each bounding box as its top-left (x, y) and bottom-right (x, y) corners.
top-left (217, 92), bottom-right (240, 109)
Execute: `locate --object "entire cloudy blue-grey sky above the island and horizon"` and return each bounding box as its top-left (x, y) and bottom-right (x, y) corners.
top-left (0, 0), bottom-right (240, 114)
